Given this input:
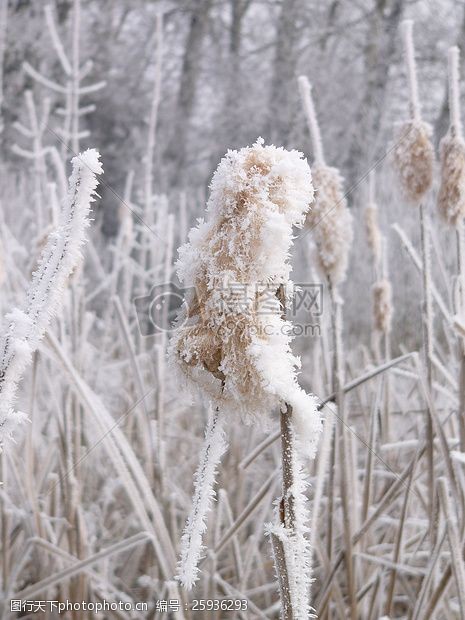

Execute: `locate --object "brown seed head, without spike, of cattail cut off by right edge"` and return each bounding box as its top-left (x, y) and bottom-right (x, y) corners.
top-left (438, 135), bottom-right (465, 226)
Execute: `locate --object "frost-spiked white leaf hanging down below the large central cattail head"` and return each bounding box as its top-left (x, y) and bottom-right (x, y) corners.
top-left (177, 409), bottom-right (227, 590)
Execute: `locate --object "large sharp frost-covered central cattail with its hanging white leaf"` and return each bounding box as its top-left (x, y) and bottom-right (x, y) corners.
top-left (170, 139), bottom-right (321, 600)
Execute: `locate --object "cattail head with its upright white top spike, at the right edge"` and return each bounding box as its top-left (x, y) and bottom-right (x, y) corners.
top-left (438, 47), bottom-right (465, 227)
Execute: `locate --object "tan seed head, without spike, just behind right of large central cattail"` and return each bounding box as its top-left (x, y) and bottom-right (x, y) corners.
top-left (306, 165), bottom-right (353, 284)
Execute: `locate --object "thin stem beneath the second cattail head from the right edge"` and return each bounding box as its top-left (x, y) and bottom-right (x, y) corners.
top-left (419, 203), bottom-right (436, 534)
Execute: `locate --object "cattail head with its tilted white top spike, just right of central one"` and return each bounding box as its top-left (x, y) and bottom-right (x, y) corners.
top-left (299, 76), bottom-right (353, 285)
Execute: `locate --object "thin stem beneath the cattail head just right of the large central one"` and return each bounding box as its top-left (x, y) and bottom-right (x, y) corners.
top-left (328, 278), bottom-right (357, 620)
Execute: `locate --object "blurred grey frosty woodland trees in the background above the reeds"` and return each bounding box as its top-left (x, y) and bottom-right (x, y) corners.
top-left (2, 0), bottom-right (465, 344)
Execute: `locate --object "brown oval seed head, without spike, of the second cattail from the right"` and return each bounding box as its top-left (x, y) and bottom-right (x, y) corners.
top-left (392, 119), bottom-right (434, 205)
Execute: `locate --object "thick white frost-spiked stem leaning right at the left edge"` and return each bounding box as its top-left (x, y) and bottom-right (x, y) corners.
top-left (0, 149), bottom-right (103, 446)
